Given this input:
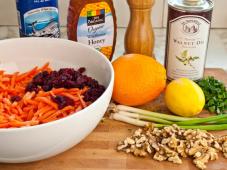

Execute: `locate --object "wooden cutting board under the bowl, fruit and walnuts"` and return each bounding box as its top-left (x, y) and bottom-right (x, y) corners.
top-left (0, 69), bottom-right (227, 170)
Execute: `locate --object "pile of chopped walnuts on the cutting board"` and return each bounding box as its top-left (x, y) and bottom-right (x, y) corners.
top-left (117, 125), bottom-right (227, 169)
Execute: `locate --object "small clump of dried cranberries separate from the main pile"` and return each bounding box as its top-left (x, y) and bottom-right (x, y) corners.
top-left (52, 95), bottom-right (75, 109)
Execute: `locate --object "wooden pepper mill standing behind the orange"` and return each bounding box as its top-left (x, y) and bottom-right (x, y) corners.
top-left (125, 0), bottom-right (155, 57)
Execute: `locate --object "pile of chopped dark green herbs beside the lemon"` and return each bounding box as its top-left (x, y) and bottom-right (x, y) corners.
top-left (197, 77), bottom-right (227, 114)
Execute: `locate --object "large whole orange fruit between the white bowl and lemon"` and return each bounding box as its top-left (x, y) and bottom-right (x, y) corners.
top-left (112, 54), bottom-right (166, 106)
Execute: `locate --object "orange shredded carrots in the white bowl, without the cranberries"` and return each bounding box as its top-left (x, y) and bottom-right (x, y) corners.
top-left (0, 63), bottom-right (89, 128)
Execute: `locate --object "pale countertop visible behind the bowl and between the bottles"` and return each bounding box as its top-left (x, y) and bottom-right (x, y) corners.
top-left (0, 26), bottom-right (227, 70)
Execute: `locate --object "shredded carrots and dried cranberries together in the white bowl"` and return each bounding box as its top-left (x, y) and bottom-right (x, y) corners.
top-left (0, 63), bottom-right (105, 128)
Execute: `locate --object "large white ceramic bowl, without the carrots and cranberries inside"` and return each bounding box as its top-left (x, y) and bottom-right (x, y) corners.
top-left (0, 38), bottom-right (114, 163)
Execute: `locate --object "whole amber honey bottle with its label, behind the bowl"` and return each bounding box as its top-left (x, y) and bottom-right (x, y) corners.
top-left (67, 0), bottom-right (117, 60)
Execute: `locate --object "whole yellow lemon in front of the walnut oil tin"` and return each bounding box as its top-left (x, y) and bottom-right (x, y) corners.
top-left (165, 78), bottom-right (205, 117)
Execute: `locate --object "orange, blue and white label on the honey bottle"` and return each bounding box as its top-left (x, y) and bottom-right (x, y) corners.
top-left (77, 2), bottom-right (114, 58)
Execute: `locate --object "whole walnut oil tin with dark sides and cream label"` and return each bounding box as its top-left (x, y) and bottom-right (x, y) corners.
top-left (165, 0), bottom-right (214, 80)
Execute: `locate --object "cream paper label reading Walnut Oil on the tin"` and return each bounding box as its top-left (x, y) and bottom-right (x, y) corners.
top-left (167, 15), bottom-right (210, 80)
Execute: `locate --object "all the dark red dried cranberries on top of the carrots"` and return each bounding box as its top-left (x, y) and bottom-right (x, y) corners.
top-left (26, 67), bottom-right (105, 103)
